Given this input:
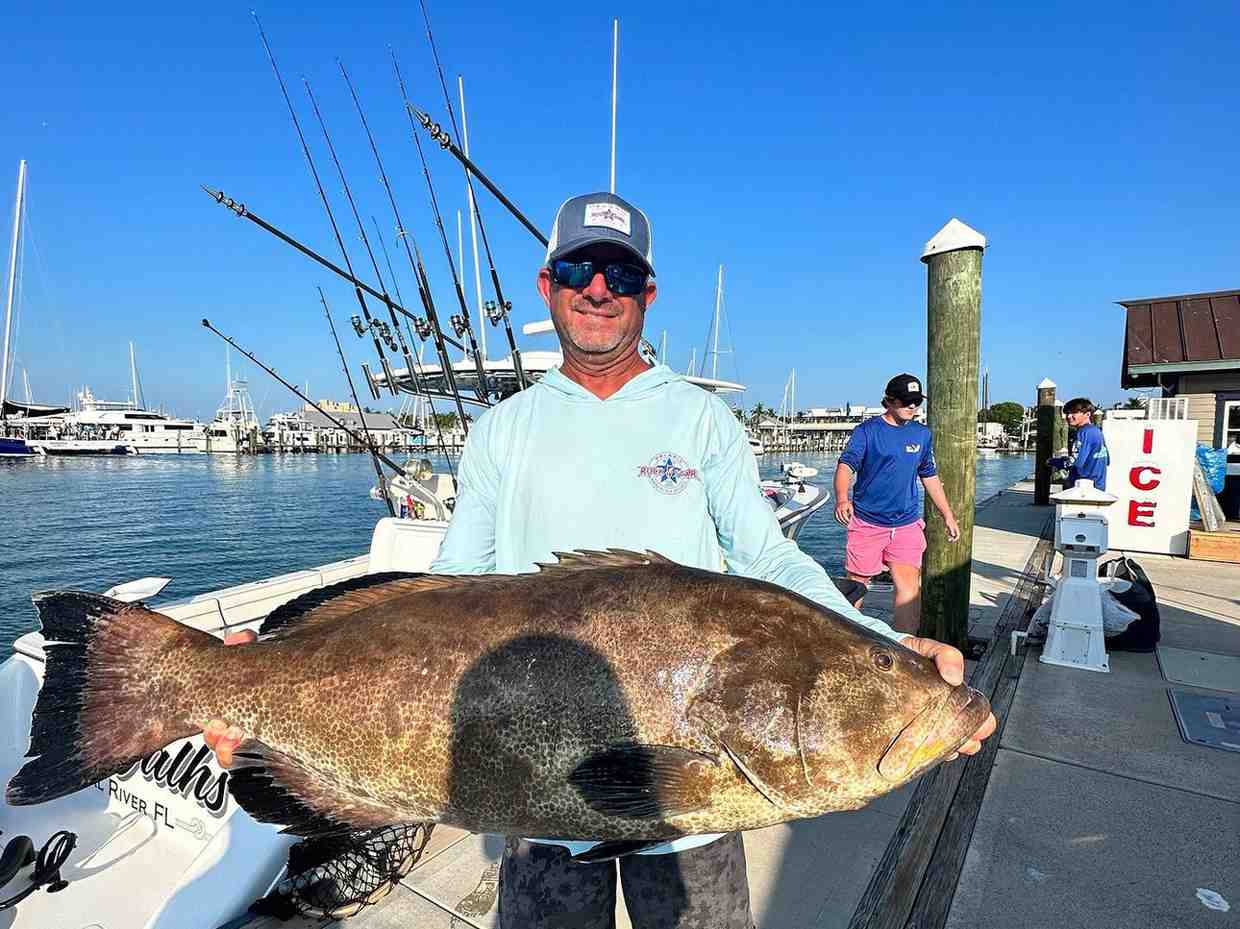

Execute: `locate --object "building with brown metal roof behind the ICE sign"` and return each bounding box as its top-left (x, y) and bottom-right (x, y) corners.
top-left (1118, 290), bottom-right (1240, 455)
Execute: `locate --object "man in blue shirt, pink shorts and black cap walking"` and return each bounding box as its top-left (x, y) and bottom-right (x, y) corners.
top-left (836, 375), bottom-right (960, 633)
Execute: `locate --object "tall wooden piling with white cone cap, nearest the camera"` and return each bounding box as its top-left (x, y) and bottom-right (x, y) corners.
top-left (918, 220), bottom-right (986, 650)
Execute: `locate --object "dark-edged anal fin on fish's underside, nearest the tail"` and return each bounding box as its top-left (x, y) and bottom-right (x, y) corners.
top-left (228, 739), bottom-right (391, 836)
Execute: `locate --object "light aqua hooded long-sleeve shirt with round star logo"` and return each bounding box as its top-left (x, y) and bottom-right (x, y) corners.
top-left (430, 365), bottom-right (904, 855)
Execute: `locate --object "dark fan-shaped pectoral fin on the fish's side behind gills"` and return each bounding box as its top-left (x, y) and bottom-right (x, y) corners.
top-left (568, 743), bottom-right (719, 820)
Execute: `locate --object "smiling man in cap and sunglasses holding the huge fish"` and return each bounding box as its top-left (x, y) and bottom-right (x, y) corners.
top-left (188, 193), bottom-right (994, 929)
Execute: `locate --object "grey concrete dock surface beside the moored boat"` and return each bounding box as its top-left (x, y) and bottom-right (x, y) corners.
top-left (244, 482), bottom-right (1240, 929)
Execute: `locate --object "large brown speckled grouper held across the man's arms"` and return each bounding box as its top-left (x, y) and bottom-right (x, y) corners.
top-left (7, 551), bottom-right (990, 858)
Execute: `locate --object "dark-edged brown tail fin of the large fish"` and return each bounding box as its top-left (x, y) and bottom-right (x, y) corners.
top-left (5, 590), bottom-right (222, 806)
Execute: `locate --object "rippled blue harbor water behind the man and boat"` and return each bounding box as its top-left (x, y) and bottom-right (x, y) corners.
top-left (0, 454), bottom-right (1033, 650)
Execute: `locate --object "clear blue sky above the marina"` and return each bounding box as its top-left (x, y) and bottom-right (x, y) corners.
top-left (0, 2), bottom-right (1240, 417)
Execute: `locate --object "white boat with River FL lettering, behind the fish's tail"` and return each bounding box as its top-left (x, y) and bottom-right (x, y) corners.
top-left (0, 474), bottom-right (450, 929)
